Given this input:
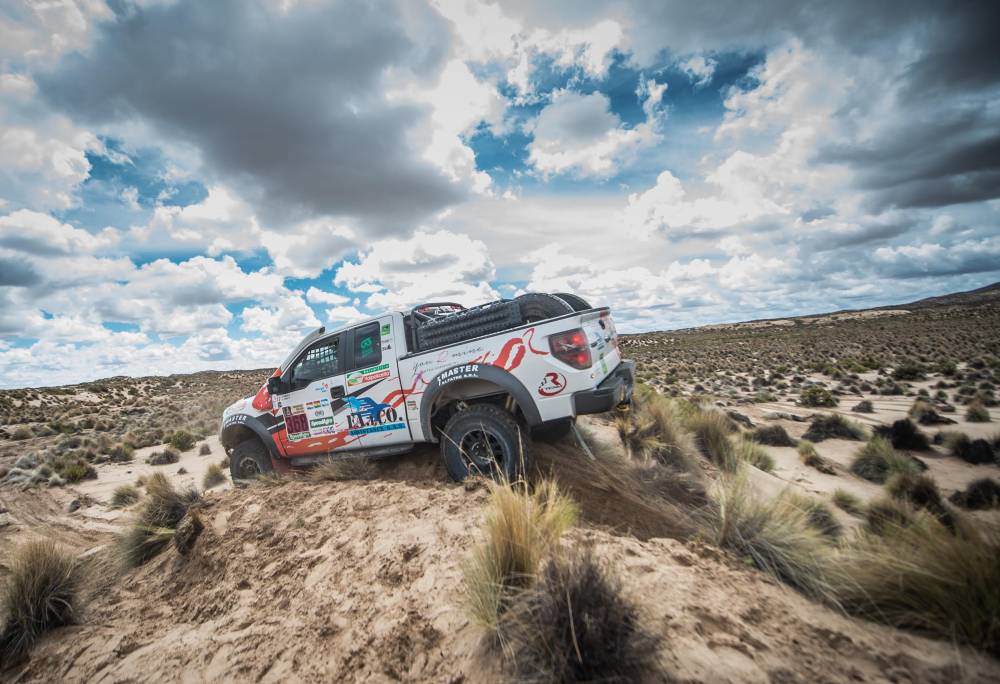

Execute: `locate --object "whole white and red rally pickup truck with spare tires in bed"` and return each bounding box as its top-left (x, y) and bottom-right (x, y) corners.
top-left (221, 293), bottom-right (635, 482)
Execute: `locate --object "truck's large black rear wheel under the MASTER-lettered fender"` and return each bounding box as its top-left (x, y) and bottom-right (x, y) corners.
top-left (440, 404), bottom-right (531, 482)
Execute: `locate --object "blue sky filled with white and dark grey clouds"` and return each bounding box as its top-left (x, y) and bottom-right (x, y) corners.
top-left (0, 0), bottom-right (1000, 386)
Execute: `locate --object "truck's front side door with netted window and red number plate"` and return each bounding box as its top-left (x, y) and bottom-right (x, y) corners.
top-left (275, 333), bottom-right (362, 456)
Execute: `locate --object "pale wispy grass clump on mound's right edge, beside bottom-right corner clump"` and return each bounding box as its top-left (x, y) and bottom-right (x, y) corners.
top-left (708, 473), bottom-right (830, 598)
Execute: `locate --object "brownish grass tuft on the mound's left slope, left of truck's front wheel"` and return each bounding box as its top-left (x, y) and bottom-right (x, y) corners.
top-left (119, 473), bottom-right (201, 567)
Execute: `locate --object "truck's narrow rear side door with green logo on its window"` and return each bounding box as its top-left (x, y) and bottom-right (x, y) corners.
top-left (345, 316), bottom-right (411, 449)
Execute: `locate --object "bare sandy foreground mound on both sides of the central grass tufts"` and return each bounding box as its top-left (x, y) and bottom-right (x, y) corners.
top-left (12, 481), bottom-right (1000, 684)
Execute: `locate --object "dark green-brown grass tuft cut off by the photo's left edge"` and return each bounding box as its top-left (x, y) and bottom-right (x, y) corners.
top-left (0, 540), bottom-right (83, 665)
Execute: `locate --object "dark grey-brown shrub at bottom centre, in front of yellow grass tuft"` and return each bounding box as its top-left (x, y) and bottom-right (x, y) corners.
top-left (501, 551), bottom-right (657, 682)
